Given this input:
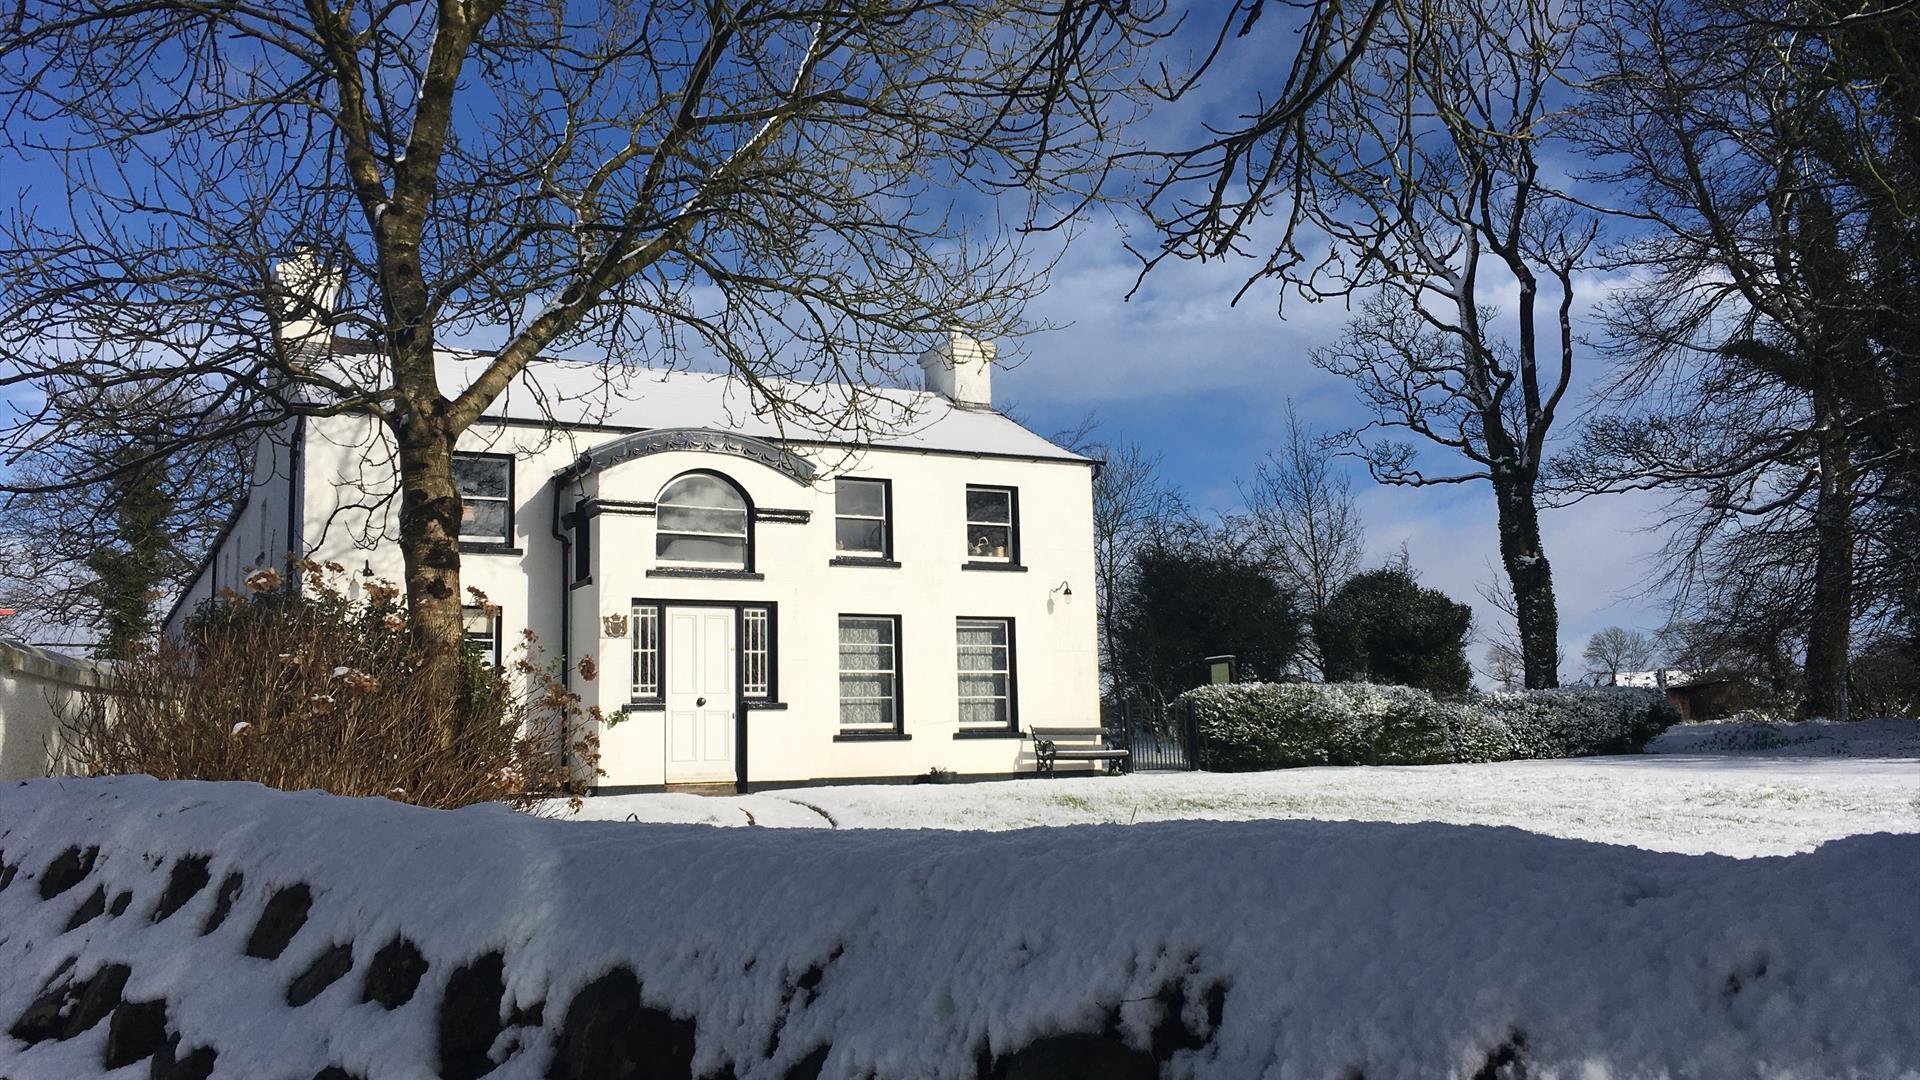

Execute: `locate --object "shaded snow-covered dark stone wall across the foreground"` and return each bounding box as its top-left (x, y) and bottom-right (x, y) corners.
top-left (0, 778), bottom-right (1920, 1080)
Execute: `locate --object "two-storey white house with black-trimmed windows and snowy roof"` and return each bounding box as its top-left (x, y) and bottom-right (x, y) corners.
top-left (167, 322), bottom-right (1098, 790)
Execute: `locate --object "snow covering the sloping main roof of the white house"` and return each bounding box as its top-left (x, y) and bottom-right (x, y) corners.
top-left (440, 350), bottom-right (1091, 461)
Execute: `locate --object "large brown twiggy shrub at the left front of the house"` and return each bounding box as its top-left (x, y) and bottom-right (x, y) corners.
top-left (65, 561), bottom-right (597, 807)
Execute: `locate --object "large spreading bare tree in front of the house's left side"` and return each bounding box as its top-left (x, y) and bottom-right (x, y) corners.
top-left (0, 0), bottom-right (1158, 707)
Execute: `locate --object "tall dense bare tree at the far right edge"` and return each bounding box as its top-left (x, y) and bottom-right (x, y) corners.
top-left (1563, 0), bottom-right (1920, 715)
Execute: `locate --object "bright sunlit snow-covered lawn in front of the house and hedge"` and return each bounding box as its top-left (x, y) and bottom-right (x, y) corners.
top-left (555, 721), bottom-right (1920, 855)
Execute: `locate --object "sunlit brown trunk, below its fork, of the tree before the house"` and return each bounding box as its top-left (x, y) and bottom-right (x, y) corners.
top-left (396, 399), bottom-right (467, 740)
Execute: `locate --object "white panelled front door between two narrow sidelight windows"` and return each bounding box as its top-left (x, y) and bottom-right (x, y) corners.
top-left (666, 607), bottom-right (737, 784)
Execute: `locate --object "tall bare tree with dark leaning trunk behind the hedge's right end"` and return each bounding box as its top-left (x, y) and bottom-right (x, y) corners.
top-left (1142, 0), bottom-right (1597, 686)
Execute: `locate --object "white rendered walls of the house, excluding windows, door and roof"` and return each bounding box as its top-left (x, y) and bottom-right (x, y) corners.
top-left (266, 407), bottom-right (1098, 788)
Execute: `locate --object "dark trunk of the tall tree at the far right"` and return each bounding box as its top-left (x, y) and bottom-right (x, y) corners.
top-left (1801, 388), bottom-right (1853, 721)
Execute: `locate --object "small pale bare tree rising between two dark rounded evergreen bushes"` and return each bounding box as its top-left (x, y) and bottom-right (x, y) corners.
top-left (1240, 400), bottom-right (1367, 615)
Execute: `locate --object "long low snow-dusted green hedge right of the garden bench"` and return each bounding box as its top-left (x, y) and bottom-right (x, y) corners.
top-left (1181, 682), bottom-right (1680, 771)
